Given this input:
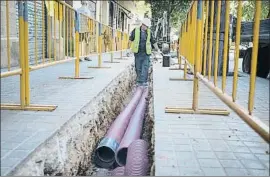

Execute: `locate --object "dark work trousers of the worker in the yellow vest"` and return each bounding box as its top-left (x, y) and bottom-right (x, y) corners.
top-left (135, 52), bottom-right (150, 85)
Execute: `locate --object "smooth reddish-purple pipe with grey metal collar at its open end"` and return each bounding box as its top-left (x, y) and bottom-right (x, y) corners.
top-left (95, 87), bottom-right (144, 168)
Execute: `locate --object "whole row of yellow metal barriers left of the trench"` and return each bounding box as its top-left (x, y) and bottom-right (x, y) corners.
top-left (1, 0), bottom-right (128, 111)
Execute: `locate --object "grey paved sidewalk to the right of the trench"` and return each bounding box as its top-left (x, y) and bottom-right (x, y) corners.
top-left (153, 63), bottom-right (269, 176)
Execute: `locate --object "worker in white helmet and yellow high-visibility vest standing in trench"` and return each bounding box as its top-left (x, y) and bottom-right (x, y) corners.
top-left (129, 18), bottom-right (160, 86)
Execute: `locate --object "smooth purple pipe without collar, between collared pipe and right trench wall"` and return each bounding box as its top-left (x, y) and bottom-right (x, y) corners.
top-left (115, 88), bottom-right (148, 166)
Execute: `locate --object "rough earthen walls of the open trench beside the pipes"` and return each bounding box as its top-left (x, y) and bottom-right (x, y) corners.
top-left (8, 65), bottom-right (154, 176)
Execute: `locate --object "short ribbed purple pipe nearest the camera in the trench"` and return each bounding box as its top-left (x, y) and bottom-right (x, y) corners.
top-left (125, 139), bottom-right (149, 176)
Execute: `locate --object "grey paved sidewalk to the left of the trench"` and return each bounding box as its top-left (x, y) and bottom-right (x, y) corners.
top-left (1, 50), bottom-right (133, 175)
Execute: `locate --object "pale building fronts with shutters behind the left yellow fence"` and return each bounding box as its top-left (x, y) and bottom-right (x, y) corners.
top-left (1, 0), bottom-right (143, 69)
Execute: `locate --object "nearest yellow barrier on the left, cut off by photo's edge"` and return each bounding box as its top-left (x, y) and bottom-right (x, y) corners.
top-left (1, 1), bottom-right (57, 111)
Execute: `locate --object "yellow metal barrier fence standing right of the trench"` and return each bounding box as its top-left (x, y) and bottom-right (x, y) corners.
top-left (165, 0), bottom-right (269, 142)
